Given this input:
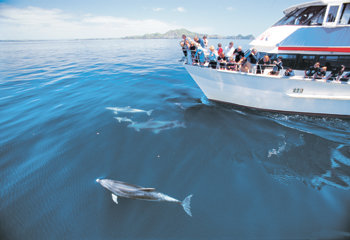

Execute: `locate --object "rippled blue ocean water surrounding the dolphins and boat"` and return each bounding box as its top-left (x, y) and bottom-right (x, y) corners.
top-left (0, 40), bottom-right (350, 239)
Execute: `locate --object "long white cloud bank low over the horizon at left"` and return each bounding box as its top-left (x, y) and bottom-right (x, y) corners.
top-left (0, 5), bottom-right (180, 40)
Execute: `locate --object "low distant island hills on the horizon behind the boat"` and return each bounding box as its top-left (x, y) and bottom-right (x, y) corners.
top-left (123, 28), bottom-right (254, 40)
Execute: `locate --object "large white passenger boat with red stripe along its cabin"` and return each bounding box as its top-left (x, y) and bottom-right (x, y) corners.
top-left (184, 0), bottom-right (350, 118)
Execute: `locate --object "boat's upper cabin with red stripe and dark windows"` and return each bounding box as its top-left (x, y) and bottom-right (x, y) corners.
top-left (250, 0), bottom-right (350, 70)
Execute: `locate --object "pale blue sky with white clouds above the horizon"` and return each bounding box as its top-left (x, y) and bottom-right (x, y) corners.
top-left (0, 0), bottom-right (305, 40)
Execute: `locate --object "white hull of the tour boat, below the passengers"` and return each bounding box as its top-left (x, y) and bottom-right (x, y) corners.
top-left (184, 65), bottom-right (350, 117)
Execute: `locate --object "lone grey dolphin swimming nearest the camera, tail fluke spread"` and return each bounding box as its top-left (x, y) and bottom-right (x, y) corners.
top-left (96, 179), bottom-right (192, 217)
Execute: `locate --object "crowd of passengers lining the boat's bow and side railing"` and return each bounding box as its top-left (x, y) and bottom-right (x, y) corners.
top-left (180, 35), bottom-right (350, 81)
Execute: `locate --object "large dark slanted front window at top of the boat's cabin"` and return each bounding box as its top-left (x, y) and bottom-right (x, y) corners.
top-left (274, 6), bottom-right (326, 26)
